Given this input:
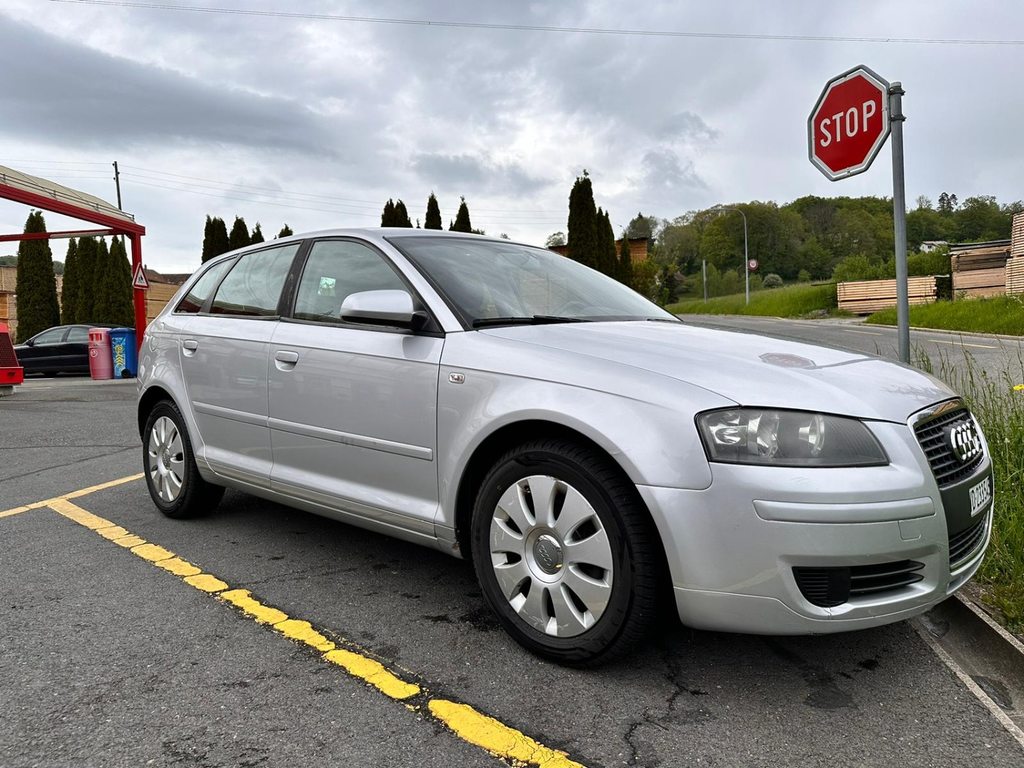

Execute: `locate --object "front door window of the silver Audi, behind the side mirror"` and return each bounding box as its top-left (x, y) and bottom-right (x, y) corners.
top-left (295, 240), bottom-right (409, 322)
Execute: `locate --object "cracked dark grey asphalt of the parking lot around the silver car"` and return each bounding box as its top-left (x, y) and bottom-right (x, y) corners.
top-left (0, 379), bottom-right (1024, 768)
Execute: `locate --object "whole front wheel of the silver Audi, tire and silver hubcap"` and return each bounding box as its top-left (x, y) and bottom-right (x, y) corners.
top-left (471, 440), bottom-right (659, 666)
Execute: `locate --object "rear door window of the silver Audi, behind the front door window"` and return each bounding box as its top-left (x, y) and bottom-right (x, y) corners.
top-left (210, 243), bottom-right (300, 317)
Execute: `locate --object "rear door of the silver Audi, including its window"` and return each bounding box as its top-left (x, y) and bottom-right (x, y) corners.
top-left (179, 243), bottom-right (300, 487)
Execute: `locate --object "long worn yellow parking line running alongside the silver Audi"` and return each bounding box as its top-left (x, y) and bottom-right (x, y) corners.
top-left (41, 495), bottom-right (584, 768)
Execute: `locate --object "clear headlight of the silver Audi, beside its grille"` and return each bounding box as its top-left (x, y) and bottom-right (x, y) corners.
top-left (697, 408), bottom-right (889, 467)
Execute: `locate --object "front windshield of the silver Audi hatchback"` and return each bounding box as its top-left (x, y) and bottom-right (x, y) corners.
top-left (389, 236), bottom-right (676, 328)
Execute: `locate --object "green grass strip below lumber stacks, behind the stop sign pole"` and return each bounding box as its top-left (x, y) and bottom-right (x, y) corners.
top-left (865, 296), bottom-right (1024, 336)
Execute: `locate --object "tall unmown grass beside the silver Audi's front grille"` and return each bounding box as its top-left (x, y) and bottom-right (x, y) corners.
top-left (911, 348), bottom-right (1024, 632)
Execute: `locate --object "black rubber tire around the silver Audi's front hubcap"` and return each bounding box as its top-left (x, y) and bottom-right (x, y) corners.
top-left (470, 439), bottom-right (663, 667)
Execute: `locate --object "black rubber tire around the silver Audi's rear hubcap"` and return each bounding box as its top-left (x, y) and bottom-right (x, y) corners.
top-left (142, 400), bottom-right (224, 519)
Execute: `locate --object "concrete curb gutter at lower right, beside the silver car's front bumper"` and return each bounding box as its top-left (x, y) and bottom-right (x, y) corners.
top-left (911, 594), bottom-right (1024, 748)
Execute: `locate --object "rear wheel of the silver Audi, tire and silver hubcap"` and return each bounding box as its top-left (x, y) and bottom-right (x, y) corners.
top-left (142, 400), bottom-right (224, 518)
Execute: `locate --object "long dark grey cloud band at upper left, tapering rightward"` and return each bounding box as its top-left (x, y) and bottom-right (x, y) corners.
top-left (0, 16), bottom-right (333, 155)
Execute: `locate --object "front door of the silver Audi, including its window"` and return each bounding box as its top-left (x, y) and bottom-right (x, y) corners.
top-left (269, 239), bottom-right (443, 536)
